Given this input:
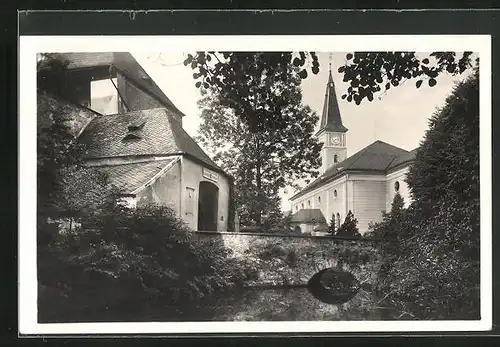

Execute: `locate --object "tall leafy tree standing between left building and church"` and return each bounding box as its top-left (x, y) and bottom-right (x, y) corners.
top-left (193, 58), bottom-right (321, 226)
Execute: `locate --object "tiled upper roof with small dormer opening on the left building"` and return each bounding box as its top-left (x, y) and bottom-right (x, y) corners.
top-left (78, 108), bottom-right (221, 171)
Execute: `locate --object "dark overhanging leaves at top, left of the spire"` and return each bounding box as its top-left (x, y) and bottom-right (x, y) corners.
top-left (184, 52), bottom-right (319, 132)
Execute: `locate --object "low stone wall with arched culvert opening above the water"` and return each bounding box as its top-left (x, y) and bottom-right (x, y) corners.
top-left (195, 231), bottom-right (383, 287)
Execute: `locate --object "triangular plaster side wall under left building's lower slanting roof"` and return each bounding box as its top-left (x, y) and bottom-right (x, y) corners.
top-left (136, 162), bottom-right (181, 214)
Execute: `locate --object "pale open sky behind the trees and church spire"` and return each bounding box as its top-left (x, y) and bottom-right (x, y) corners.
top-left (131, 52), bottom-right (472, 211)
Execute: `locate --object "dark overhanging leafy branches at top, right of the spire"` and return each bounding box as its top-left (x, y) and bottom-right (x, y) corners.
top-left (338, 52), bottom-right (472, 105)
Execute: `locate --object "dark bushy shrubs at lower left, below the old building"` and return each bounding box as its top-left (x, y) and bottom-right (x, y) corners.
top-left (39, 205), bottom-right (252, 319)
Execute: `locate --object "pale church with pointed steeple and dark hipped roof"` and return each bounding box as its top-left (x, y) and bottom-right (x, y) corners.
top-left (290, 67), bottom-right (416, 234)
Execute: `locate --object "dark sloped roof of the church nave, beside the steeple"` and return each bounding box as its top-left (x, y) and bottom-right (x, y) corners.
top-left (290, 140), bottom-right (412, 200)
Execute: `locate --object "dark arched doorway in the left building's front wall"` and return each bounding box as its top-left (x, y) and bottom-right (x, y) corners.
top-left (198, 181), bottom-right (219, 231)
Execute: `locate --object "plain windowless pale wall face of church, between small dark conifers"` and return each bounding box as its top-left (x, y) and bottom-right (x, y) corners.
top-left (351, 175), bottom-right (386, 234)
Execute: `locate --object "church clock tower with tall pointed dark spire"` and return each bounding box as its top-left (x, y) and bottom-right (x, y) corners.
top-left (316, 62), bottom-right (347, 174)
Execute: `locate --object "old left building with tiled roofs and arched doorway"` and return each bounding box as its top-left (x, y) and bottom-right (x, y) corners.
top-left (38, 53), bottom-right (231, 230)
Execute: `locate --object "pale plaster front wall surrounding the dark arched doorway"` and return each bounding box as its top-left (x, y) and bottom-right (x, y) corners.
top-left (181, 158), bottom-right (229, 231)
